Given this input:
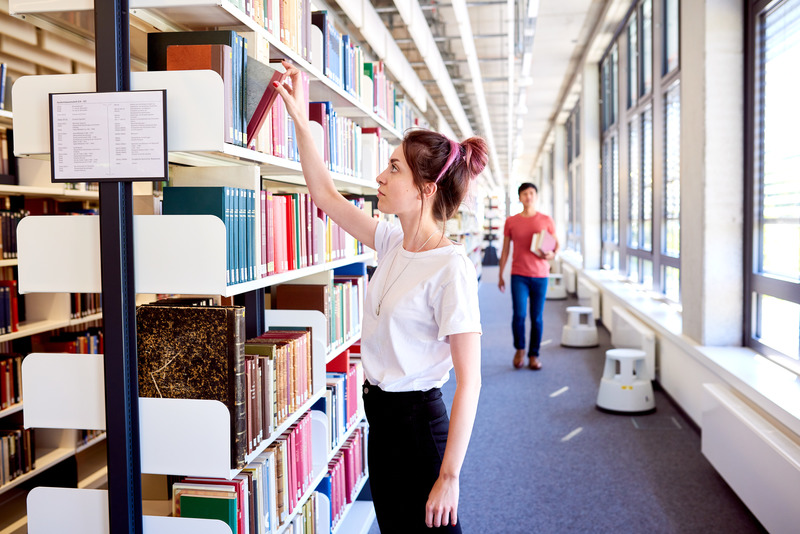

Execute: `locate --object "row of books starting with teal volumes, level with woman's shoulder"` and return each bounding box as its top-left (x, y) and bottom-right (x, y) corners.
top-left (162, 186), bottom-right (371, 285)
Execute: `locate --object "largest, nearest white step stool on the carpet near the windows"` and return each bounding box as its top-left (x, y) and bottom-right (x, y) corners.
top-left (597, 349), bottom-right (656, 413)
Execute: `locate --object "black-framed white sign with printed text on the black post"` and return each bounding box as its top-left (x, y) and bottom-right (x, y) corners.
top-left (50, 90), bottom-right (168, 182)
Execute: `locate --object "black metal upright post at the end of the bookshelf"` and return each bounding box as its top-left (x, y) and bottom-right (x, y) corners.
top-left (95, 0), bottom-right (142, 534)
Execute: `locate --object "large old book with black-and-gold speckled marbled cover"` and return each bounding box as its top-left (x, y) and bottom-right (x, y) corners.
top-left (136, 303), bottom-right (247, 469)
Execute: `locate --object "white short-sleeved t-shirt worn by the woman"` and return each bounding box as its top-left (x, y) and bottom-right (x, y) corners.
top-left (361, 221), bottom-right (481, 391)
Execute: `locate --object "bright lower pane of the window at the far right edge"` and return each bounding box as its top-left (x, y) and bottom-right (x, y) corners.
top-left (756, 295), bottom-right (800, 359)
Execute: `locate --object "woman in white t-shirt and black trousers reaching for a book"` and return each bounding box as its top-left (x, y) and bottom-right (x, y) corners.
top-left (276, 62), bottom-right (488, 534)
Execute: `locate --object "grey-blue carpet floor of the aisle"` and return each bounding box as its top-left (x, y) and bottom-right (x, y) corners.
top-left (369, 267), bottom-right (764, 534)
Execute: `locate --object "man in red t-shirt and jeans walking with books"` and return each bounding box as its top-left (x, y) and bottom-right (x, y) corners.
top-left (497, 182), bottom-right (558, 371)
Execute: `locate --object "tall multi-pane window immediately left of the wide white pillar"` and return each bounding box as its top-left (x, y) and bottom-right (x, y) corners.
top-left (600, 0), bottom-right (680, 302)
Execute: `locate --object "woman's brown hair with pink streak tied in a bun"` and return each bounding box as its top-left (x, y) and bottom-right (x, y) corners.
top-left (403, 130), bottom-right (489, 222)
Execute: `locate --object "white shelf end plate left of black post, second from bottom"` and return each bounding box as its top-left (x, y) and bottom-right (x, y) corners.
top-left (22, 353), bottom-right (106, 430)
